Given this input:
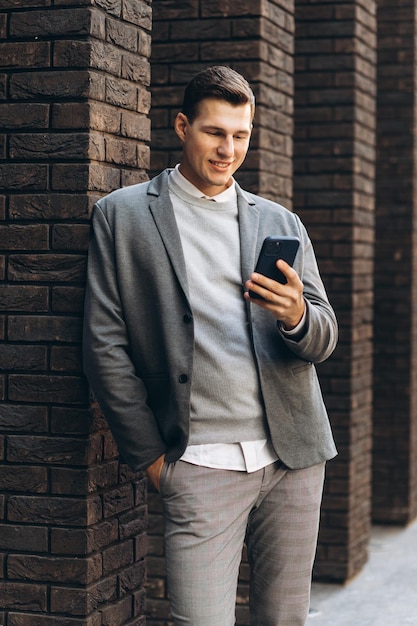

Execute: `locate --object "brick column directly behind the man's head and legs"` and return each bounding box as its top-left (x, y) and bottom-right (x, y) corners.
top-left (148, 0), bottom-right (294, 626)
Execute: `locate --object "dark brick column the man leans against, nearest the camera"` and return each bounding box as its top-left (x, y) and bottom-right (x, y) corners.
top-left (0, 0), bottom-right (151, 626)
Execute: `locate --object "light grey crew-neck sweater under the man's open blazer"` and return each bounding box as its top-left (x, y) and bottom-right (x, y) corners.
top-left (169, 173), bottom-right (267, 445)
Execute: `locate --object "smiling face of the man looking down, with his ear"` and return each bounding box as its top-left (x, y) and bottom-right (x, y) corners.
top-left (175, 98), bottom-right (252, 196)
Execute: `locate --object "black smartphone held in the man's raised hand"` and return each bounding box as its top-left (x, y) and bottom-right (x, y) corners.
top-left (249, 237), bottom-right (300, 299)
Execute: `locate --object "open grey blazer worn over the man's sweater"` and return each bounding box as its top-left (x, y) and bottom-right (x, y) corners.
top-left (83, 170), bottom-right (337, 470)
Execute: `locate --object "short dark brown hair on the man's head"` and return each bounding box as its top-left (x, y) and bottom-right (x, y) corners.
top-left (181, 65), bottom-right (255, 122)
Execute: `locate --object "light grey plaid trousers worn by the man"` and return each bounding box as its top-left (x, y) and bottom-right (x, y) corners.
top-left (161, 461), bottom-right (325, 626)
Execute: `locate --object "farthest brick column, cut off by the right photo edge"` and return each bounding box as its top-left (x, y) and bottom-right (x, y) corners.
top-left (373, 0), bottom-right (417, 523)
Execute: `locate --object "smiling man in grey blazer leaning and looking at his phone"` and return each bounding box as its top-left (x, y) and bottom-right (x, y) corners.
top-left (84, 67), bottom-right (337, 626)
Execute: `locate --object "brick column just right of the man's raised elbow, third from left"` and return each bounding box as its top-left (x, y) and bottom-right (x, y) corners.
top-left (294, 0), bottom-right (376, 581)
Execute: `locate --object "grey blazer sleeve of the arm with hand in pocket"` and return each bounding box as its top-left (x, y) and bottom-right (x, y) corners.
top-left (83, 205), bottom-right (165, 471)
